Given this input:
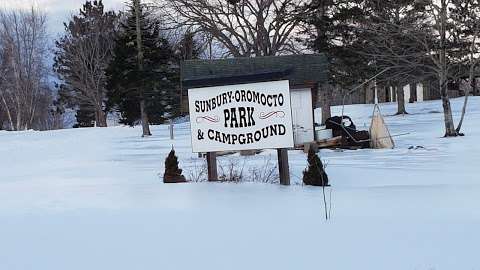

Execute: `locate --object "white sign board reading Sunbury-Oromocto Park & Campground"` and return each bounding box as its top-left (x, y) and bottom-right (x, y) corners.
top-left (188, 81), bottom-right (293, 152)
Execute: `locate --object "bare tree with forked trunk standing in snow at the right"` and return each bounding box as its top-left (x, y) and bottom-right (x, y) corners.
top-left (358, 0), bottom-right (478, 137)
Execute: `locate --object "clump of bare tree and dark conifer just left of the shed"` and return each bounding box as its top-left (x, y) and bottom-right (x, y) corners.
top-left (54, 0), bottom-right (199, 136)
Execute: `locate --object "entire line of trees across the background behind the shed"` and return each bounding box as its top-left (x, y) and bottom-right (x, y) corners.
top-left (0, 0), bottom-right (480, 136)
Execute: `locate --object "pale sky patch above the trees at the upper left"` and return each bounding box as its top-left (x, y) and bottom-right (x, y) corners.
top-left (0, 0), bottom-right (127, 37)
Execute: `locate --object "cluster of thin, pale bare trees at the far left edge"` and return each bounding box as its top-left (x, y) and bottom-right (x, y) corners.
top-left (0, 8), bottom-right (51, 130)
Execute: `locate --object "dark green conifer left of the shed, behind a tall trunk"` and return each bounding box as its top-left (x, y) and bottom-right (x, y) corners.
top-left (107, 2), bottom-right (180, 125)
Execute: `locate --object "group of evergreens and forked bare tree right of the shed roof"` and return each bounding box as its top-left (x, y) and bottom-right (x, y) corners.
top-left (300, 0), bottom-right (480, 136)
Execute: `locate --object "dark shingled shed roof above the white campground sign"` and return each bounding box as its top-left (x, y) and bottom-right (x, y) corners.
top-left (181, 54), bottom-right (328, 89)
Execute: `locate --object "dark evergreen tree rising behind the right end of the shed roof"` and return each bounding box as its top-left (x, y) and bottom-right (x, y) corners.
top-left (304, 0), bottom-right (371, 89)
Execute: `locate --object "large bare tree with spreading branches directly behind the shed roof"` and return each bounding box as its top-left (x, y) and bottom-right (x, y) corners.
top-left (159, 0), bottom-right (304, 57)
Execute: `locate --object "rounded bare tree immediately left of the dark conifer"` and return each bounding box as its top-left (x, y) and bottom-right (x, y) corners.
top-left (54, 1), bottom-right (117, 127)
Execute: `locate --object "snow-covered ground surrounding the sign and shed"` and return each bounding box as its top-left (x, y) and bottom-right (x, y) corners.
top-left (0, 97), bottom-right (480, 270)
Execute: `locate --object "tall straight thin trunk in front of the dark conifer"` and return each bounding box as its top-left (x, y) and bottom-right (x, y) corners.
top-left (133, 0), bottom-right (152, 137)
